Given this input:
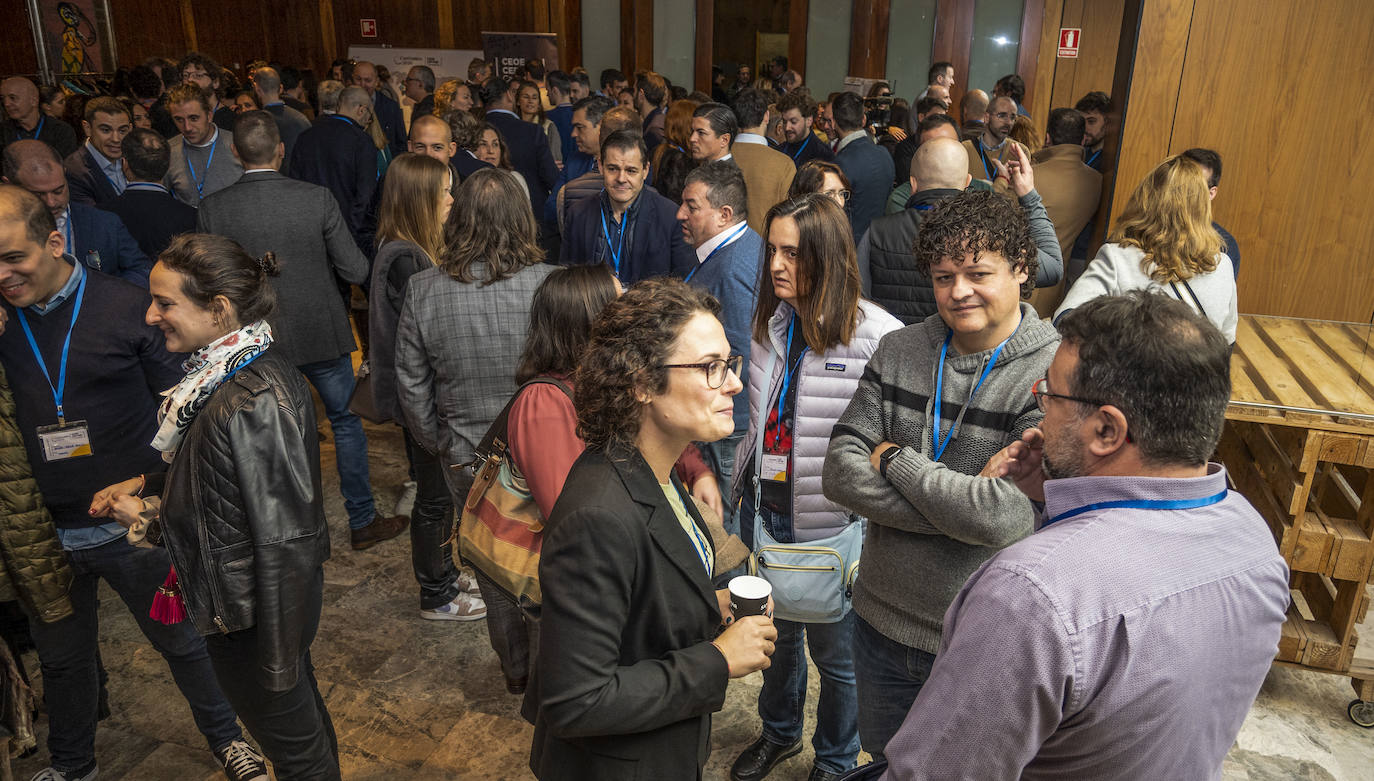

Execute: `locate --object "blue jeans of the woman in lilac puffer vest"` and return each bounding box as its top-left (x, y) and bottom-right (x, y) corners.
top-left (739, 487), bottom-right (859, 773)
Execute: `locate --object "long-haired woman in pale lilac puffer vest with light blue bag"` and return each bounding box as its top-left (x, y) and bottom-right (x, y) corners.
top-left (731, 194), bottom-right (901, 780)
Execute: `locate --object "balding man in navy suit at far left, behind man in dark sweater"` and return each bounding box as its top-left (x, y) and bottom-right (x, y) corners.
top-left (4, 139), bottom-right (153, 290)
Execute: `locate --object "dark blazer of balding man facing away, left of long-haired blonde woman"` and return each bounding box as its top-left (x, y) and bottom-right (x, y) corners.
top-left (289, 114), bottom-right (378, 250)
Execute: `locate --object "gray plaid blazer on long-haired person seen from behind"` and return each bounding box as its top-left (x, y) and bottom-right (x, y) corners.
top-left (396, 263), bottom-right (554, 473)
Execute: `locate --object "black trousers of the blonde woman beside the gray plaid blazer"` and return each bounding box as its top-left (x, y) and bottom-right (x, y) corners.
top-left (401, 428), bottom-right (458, 611)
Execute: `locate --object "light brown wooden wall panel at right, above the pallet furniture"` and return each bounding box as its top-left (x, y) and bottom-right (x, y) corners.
top-left (1165, 0), bottom-right (1374, 322)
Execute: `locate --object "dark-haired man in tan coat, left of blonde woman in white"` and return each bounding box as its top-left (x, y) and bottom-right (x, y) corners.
top-left (1031, 109), bottom-right (1102, 318)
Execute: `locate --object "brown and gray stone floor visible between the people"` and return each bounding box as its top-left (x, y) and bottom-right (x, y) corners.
top-left (14, 418), bottom-right (1374, 781)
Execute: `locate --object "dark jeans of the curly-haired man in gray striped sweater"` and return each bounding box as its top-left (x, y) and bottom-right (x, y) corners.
top-left (853, 616), bottom-right (936, 759)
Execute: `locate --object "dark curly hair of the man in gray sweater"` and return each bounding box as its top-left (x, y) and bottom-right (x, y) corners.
top-left (911, 190), bottom-right (1039, 298)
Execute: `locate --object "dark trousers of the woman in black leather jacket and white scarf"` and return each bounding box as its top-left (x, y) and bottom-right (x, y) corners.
top-left (205, 568), bottom-right (339, 781)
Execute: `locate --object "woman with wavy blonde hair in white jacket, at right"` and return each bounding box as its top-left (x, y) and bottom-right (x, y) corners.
top-left (1054, 155), bottom-right (1237, 344)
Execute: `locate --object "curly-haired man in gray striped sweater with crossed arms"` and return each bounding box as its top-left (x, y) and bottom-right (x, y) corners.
top-left (823, 185), bottom-right (1059, 758)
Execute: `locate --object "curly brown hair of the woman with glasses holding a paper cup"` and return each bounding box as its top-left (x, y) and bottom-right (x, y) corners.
top-left (573, 276), bottom-right (720, 455)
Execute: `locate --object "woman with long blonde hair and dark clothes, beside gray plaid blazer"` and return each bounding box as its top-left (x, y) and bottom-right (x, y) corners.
top-left (367, 153), bottom-right (486, 622)
